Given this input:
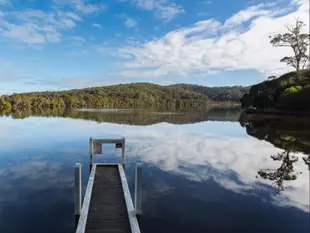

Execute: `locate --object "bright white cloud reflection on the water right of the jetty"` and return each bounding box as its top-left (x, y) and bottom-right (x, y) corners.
top-left (126, 130), bottom-right (309, 211)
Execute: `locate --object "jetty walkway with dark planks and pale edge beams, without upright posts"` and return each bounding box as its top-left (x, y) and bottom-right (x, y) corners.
top-left (76, 164), bottom-right (140, 233)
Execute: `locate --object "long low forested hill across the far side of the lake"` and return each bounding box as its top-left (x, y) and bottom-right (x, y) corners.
top-left (0, 83), bottom-right (247, 109)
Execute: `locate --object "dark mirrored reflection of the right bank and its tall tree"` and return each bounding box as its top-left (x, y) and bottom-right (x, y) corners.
top-left (239, 114), bottom-right (310, 192)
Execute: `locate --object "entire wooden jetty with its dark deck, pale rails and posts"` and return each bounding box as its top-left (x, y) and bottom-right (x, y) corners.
top-left (75, 138), bottom-right (142, 233)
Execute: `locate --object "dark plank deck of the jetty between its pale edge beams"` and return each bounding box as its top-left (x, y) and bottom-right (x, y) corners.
top-left (85, 165), bottom-right (131, 233)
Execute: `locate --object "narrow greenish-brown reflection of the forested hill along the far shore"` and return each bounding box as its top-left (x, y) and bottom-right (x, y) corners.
top-left (0, 108), bottom-right (240, 125)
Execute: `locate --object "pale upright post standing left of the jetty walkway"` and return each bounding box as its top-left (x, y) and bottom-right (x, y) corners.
top-left (74, 163), bottom-right (82, 217)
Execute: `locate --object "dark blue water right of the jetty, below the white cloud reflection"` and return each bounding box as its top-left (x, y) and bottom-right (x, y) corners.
top-left (136, 167), bottom-right (309, 233)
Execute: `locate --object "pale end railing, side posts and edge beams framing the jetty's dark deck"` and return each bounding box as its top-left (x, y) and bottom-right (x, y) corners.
top-left (74, 138), bottom-right (142, 233)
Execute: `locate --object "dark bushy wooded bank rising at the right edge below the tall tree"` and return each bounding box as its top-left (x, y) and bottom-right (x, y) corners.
top-left (241, 69), bottom-right (310, 112)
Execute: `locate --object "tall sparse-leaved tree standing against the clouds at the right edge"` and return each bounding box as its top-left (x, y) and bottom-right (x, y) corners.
top-left (270, 18), bottom-right (310, 72)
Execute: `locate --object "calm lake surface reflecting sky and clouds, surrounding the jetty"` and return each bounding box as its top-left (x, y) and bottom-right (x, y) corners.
top-left (0, 109), bottom-right (310, 233)
